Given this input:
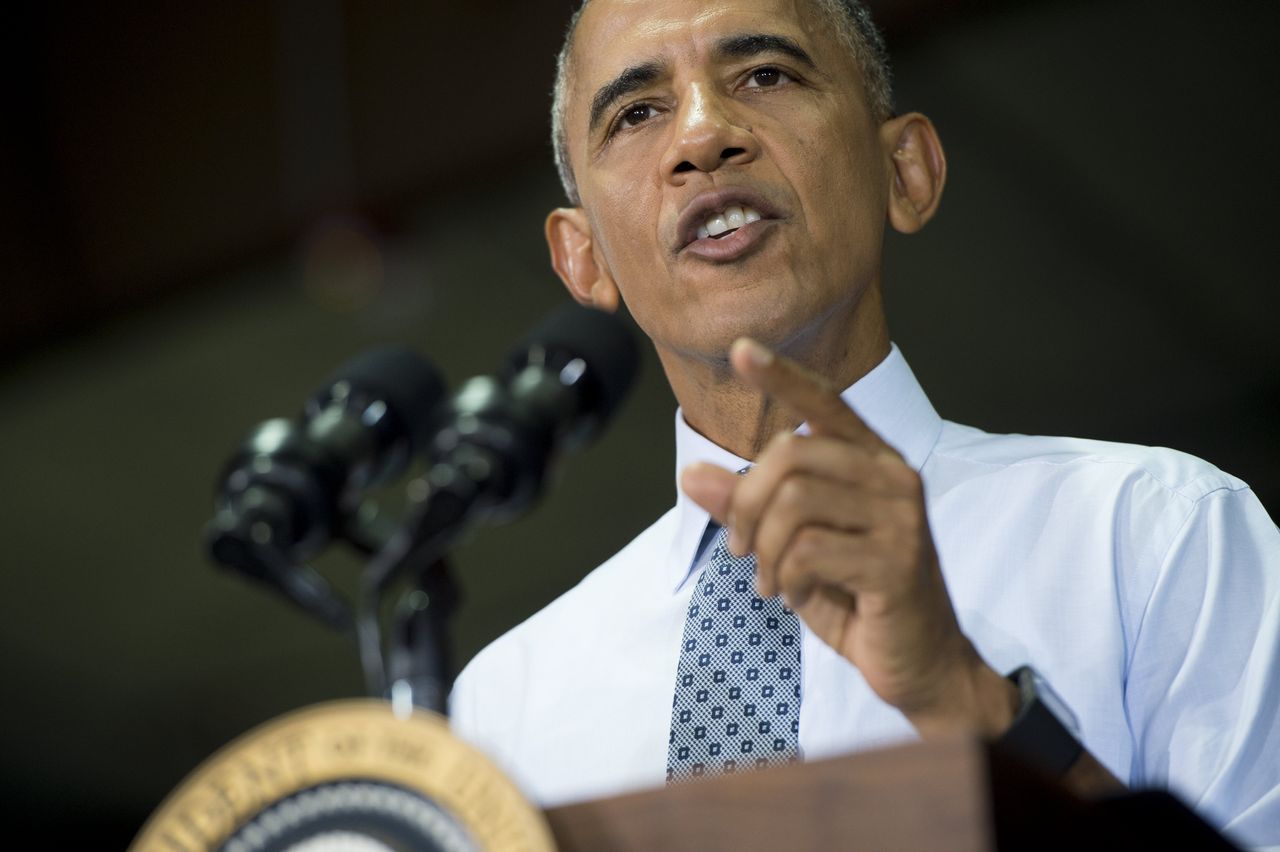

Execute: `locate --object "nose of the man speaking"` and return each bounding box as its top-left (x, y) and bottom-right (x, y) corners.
top-left (662, 83), bottom-right (759, 184)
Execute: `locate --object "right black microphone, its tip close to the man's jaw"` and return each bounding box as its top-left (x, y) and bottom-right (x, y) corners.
top-left (371, 303), bottom-right (639, 587)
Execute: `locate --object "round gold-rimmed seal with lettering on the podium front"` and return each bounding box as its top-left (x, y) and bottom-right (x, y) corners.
top-left (131, 698), bottom-right (556, 852)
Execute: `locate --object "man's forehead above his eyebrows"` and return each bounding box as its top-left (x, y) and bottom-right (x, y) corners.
top-left (573, 0), bottom-right (831, 101)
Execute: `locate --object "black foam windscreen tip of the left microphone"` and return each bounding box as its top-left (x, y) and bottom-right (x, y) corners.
top-left (314, 345), bottom-right (445, 446)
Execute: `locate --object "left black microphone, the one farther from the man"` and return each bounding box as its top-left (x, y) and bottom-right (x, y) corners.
top-left (205, 347), bottom-right (444, 627)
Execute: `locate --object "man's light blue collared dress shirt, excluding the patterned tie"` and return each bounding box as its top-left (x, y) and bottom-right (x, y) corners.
top-left (452, 347), bottom-right (1280, 848)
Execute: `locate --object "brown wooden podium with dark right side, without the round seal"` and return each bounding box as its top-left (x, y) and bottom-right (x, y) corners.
top-left (545, 741), bottom-right (1235, 852)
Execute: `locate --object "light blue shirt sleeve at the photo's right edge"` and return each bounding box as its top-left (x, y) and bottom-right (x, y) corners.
top-left (1125, 487), bottom-right (1280, 849)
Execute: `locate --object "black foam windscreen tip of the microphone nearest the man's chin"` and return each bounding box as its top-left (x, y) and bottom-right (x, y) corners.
top-left (508, 302), bottom-right (640, 418)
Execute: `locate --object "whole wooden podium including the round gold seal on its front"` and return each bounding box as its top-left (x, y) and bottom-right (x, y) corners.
top-left (131, 698), bottom-right (1233, 852)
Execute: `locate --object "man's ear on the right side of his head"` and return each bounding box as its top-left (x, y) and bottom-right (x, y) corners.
top-left (881, 113), bottom-right (947, 234)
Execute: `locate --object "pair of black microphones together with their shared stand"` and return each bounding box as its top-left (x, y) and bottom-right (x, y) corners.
top-left (206, 304), bottom-right (639, 714)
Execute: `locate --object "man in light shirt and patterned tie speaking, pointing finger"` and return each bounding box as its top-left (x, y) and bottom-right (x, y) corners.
top-left (453, 0), bottom-right (1280, 844)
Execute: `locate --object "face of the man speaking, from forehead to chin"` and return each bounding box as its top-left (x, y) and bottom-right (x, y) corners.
top-left (566, 0), bottom-right (892, 361)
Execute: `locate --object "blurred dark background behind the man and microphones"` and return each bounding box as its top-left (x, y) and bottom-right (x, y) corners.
top-left (0, 0), bottom-right (1280, 848)
